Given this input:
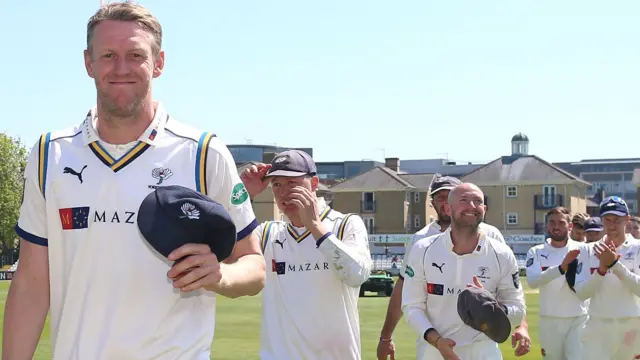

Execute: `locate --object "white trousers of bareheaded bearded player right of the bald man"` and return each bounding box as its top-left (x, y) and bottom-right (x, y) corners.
top-left (538, 315), bottom-right (587, 360)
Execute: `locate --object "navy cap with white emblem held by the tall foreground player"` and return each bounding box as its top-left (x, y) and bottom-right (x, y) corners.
top-left (138, 185), bottom-right (237, 261)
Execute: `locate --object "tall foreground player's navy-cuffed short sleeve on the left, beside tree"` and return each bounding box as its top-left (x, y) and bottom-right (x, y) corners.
top-left (15, 139), bottom-right (48, 246)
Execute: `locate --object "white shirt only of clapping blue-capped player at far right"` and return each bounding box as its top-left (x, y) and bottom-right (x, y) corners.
top-left (575, 234), bottom-right (640, 319)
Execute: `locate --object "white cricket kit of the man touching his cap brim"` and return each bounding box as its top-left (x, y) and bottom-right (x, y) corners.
top-left (258, 198), bottom-right (372, 360)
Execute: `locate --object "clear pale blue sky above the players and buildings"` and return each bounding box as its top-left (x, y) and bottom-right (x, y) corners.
top-left (0, 0), bottom-right (640, 162)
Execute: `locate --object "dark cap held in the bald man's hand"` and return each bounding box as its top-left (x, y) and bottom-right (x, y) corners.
top-left (458, 287), bottom-right (511, 344)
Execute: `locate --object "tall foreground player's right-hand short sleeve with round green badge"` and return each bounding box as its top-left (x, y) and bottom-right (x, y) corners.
top-left (206, 137), bottom-right (258, 240)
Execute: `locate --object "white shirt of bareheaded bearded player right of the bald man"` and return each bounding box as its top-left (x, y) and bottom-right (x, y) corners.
top-left (526, 239), bottom-right (589, 317)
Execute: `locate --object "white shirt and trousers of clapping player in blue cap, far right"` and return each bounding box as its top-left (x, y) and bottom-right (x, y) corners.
top-left (575, 234), bottom-right (640, 360)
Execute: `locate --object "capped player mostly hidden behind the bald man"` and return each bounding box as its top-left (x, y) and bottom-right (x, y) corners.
top-left (377, 174), bottom-right (531, 360)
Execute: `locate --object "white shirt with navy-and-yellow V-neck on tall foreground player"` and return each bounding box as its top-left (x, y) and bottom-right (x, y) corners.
top-left (16, 104), bottom-right (258, 360)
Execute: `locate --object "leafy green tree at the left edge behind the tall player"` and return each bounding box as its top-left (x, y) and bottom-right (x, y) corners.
top-left (0, 133), bottom-right (28, 253)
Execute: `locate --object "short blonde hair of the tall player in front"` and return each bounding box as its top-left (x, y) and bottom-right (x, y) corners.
top-left (87, 2), bottom-right (162, 56)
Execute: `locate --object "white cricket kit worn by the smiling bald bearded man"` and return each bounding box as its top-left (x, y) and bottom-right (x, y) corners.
top-left (402, 229), bottom-right (526, 360)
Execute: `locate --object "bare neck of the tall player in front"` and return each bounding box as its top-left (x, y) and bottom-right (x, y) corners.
top-left (96, 103), bottom-right (156, 145)
